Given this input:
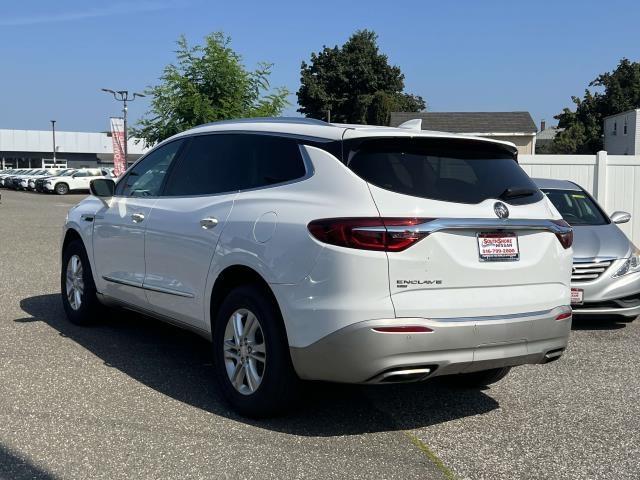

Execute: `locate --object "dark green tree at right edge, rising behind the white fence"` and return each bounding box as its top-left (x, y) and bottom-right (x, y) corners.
top-left (550, 58), bottom-right (640, 154)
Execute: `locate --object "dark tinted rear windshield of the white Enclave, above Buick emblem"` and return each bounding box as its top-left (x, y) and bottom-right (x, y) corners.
top-left (345, 138), bottom-right (543, 205)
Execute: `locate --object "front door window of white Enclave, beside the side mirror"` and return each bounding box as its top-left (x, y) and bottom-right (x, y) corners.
top-left (116, 140), bottom-right (183, 197)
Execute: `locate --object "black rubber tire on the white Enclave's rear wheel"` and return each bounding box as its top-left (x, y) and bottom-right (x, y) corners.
top-left (212, 285), bottom-right (299, 418)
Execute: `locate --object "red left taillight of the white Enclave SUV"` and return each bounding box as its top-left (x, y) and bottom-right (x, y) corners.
top-left (308, 217), bottom-right (431, 252)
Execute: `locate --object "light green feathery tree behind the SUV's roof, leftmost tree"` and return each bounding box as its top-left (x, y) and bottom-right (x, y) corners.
top-left (132, 32), bottom-right (289, 144)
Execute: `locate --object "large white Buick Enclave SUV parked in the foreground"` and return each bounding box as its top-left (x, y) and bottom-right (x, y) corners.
top-left (61, 119), bottom-right (572, 416)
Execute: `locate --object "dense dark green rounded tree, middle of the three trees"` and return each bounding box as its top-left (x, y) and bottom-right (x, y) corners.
top-left (298, 30), bottom-right (426, 125)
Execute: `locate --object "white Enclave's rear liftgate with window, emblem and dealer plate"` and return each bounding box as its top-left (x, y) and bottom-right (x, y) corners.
top-left (345, 137), bottom-right (571, 318)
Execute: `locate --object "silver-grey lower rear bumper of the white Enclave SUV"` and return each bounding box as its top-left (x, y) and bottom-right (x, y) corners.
top-left (290, 307), bottom-right (571, 383)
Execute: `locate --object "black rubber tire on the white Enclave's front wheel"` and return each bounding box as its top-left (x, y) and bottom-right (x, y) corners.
top-left (60, 240), bottom-right (101, 325)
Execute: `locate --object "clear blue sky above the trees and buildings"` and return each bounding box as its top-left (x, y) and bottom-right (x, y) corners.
top-left (0, 0), bottom-right (640, 131)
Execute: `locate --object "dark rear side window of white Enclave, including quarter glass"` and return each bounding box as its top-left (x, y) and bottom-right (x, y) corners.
top-left (164, 134), bottom-right (305, 195)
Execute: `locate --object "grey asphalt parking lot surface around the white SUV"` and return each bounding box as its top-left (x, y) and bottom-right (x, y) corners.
top-left (0, 190), bottom-right (640, 479)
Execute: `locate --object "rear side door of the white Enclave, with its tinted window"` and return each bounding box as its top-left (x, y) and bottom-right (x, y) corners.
top-left (144, 134), bottom-right (239, 329)
